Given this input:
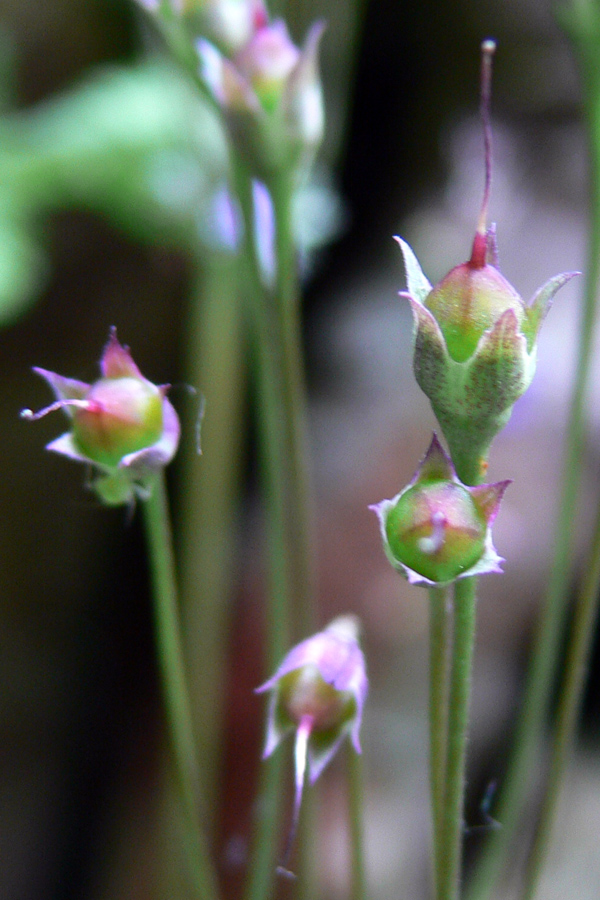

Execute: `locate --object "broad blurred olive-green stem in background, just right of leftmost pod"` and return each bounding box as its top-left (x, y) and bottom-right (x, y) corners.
top-left (178, 251), bottom-right (246, 827)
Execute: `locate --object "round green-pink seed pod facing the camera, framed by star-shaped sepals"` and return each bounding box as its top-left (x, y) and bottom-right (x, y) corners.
top-left (370, 435), bottom-right (510, 585)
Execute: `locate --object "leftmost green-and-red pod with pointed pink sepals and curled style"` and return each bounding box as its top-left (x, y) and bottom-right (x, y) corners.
top-left (22, 329), bottom-right (180, 505)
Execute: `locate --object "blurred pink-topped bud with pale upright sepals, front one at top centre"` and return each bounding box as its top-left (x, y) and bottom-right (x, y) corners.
top-left (197, 21), bottom-right (324, 181)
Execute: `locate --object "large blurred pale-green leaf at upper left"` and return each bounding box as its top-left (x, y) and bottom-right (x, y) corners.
top-left (0, 62), bottom-right (228, 323)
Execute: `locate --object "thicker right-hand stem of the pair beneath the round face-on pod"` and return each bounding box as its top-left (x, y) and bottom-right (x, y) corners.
top-left (437, 578), bottom-right (477, 900)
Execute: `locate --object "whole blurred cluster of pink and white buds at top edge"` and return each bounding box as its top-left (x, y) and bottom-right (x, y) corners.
top-left (138, 0), bottom-right (325, 181)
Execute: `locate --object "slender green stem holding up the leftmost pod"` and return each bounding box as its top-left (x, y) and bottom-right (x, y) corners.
top-left (142, 472), bottom-right (219, 900)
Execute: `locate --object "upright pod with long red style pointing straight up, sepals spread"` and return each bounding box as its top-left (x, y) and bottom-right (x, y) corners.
top-left (397, 41), bottom-right (577, 483)
